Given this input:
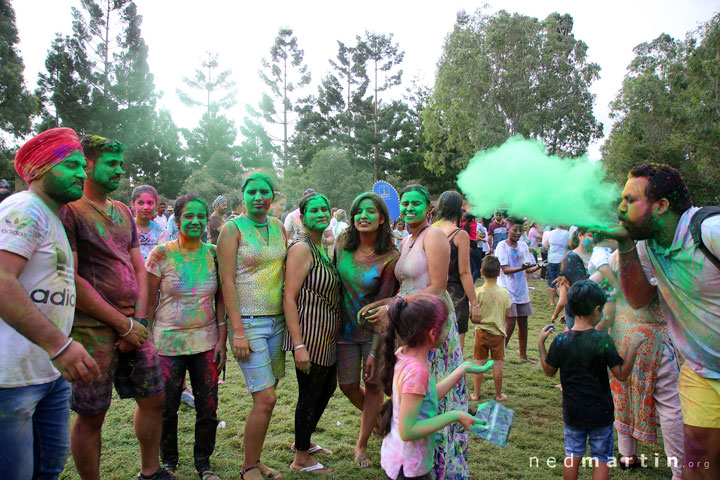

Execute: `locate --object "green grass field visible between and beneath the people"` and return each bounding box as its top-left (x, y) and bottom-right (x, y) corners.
top-left (61, 280), bottom-right (671, 480)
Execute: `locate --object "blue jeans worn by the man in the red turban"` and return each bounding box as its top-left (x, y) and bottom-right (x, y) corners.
top-left (0, 377), bottom-right (72, 480)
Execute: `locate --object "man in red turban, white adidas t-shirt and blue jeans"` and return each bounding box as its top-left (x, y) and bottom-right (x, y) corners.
top-left (0, 128), bottom-right (100, 478)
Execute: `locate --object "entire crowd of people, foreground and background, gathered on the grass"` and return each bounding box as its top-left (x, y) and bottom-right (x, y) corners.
top-left (0, 128), bottom-right (720, 480)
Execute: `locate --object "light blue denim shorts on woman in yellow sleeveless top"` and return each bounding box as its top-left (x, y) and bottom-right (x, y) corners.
top-left (233, 314), bottom-right (285, 393)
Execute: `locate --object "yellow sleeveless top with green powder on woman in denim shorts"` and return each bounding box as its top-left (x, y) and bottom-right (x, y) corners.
top-left (232, 215), bottom-right (286, 315)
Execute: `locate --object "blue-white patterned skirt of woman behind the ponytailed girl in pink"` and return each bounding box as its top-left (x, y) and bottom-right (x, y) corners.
top-left (400, 291), bottom-right (470, 480)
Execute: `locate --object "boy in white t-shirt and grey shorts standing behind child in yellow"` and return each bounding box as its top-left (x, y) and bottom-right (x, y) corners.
top-left (495, 216), bottom-right (540, 363)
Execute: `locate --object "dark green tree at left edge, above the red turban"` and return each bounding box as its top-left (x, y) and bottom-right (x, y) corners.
top-left (0, 0), bottom-right (37, 137)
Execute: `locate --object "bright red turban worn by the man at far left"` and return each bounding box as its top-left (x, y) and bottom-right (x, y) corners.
top-left (15, 128), bottom-right (82, 183)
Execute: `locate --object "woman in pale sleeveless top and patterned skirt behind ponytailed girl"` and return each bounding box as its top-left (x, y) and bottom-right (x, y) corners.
top-left (360, 185), bottom-right (470, 480)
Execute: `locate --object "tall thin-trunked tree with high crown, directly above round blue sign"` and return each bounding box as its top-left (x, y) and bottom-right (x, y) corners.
top-left (357, 31), bottom-right (405, 181)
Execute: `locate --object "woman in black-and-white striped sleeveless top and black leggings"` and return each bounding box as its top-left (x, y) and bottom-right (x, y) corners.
top-left (283, 192), bottom-right (340, 473)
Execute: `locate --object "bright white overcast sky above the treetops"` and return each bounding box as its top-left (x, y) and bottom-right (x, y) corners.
top-left (11, 0), bottom-right (720, 158)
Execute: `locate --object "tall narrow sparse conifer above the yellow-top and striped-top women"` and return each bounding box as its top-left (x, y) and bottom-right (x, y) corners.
top-left (258, 28), bottom-right (310, 167)
